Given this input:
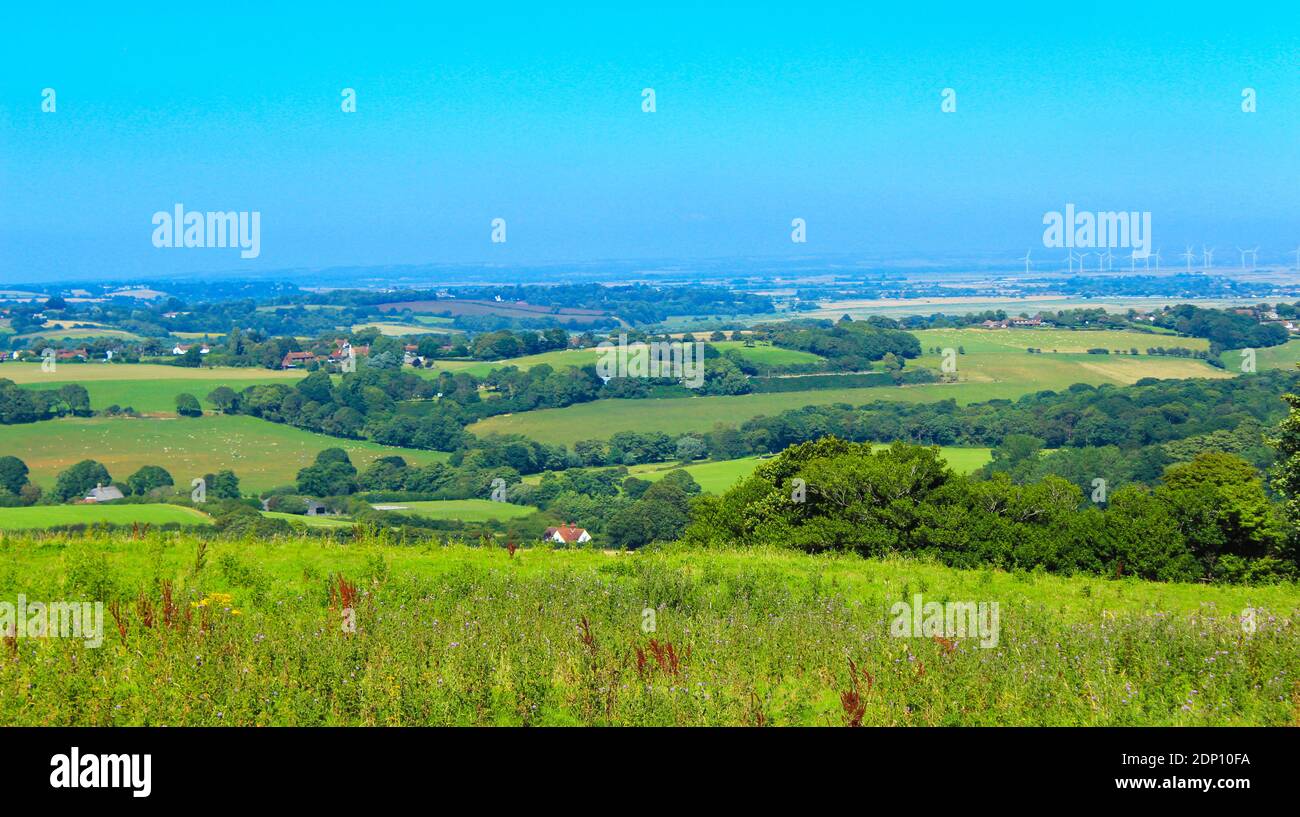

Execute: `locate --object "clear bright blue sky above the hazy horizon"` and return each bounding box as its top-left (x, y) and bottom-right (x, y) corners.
top-left (0, 3), bottom-right (1300, 281)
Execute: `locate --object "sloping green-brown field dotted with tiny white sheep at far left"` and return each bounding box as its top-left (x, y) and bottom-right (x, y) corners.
top-left (0, 415), bottom-right (447, 493)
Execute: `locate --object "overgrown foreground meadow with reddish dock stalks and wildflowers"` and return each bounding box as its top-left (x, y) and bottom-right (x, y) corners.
top-left (0, 533), bottom-right (1300, 726)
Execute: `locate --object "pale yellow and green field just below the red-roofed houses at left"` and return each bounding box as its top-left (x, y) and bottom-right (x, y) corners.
top-left (0, 363), bottom-right (306, 414)
